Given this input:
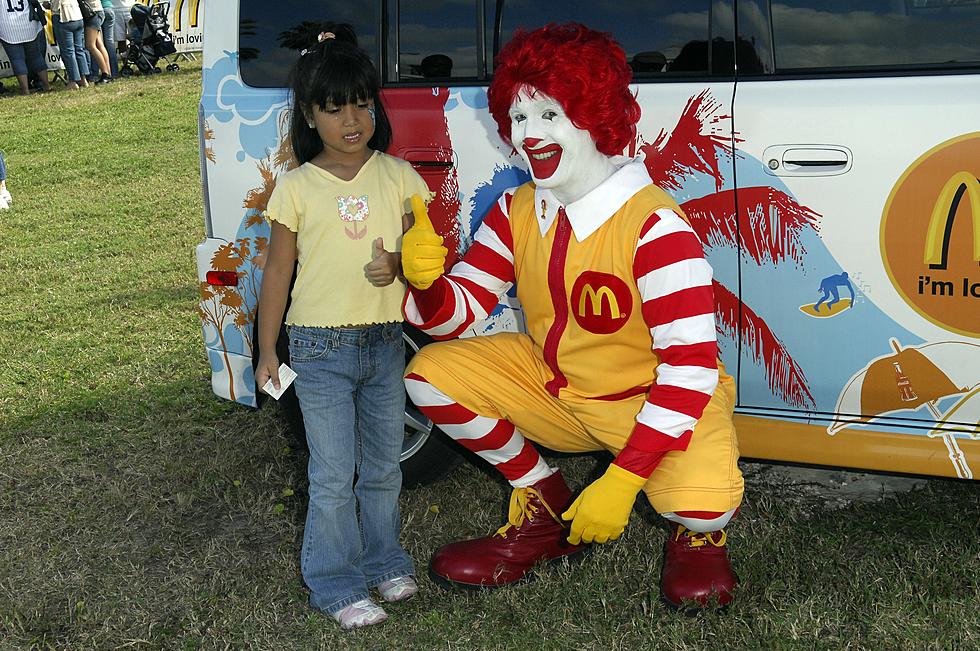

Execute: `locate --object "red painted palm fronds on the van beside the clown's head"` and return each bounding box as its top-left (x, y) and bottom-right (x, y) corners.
top-left (638, 90), bottom-right (820, 408)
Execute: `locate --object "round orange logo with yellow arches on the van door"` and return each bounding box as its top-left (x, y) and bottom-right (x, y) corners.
top-left (880, 132), bottom-right (980, 337)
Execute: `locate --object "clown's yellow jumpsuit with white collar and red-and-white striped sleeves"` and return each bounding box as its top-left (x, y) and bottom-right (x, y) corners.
top-left (405, 160), bottom-right (742, 528)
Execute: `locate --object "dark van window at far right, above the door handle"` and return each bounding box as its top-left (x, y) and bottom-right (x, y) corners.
top-left (772, 0), bottom-right (980, 72)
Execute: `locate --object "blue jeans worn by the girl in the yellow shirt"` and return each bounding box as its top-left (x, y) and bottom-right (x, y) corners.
top-left (289, 323), bottom-right (415, 613)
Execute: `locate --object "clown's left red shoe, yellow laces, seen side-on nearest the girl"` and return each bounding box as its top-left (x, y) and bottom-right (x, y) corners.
top-left (429, 471), bottom-right (585, 588)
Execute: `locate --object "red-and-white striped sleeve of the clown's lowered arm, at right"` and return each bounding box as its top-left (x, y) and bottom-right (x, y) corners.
top-left (614, 209), bottom-right (718, 477)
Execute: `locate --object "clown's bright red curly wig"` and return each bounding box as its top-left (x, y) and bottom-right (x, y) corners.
top-left (487, 23), bottom-right (640, 156)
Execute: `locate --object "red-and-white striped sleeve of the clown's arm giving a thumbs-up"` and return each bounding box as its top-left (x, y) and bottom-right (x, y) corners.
top-left (405, 189), bottom-right (514, 339)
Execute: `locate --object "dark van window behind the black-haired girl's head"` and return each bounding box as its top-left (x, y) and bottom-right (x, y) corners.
top-left (238, 0), bottom-right (380, 88)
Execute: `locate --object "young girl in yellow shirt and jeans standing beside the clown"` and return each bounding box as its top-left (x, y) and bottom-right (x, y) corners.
top-left (256, 26), bottom-right (429, 629)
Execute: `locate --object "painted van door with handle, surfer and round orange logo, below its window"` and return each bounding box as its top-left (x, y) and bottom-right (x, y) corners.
top-left (735, 74), bottom-right (980, 478)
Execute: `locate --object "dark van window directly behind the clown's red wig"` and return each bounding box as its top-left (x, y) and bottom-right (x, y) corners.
top-left (486, 0), bottom-right (713, 79)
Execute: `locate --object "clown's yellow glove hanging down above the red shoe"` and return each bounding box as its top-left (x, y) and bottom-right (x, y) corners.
top-left (561, 464), bottom-right (647, 545)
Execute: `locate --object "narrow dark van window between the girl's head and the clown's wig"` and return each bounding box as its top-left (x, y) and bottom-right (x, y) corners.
top-left (398, 0), bottom-right (479, 81)
